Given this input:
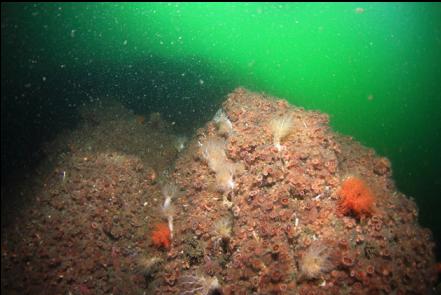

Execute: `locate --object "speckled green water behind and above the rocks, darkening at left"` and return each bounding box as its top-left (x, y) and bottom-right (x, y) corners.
top-left (1, 3), bottom-right (441, 254)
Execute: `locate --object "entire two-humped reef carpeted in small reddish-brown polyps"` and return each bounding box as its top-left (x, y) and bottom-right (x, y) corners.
top-left (2, 88), bottom-right (440, 294)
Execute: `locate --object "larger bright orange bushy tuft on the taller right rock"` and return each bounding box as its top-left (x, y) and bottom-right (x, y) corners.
top-left (338, 176), bottom-right (375, 217)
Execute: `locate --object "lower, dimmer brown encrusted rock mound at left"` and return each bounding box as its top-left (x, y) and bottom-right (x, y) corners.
top-left (1, 102), bottom-right (178, 295)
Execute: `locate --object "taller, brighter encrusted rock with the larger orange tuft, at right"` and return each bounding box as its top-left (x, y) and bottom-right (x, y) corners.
top-left (156, 88), bottom-right (437, 294)
